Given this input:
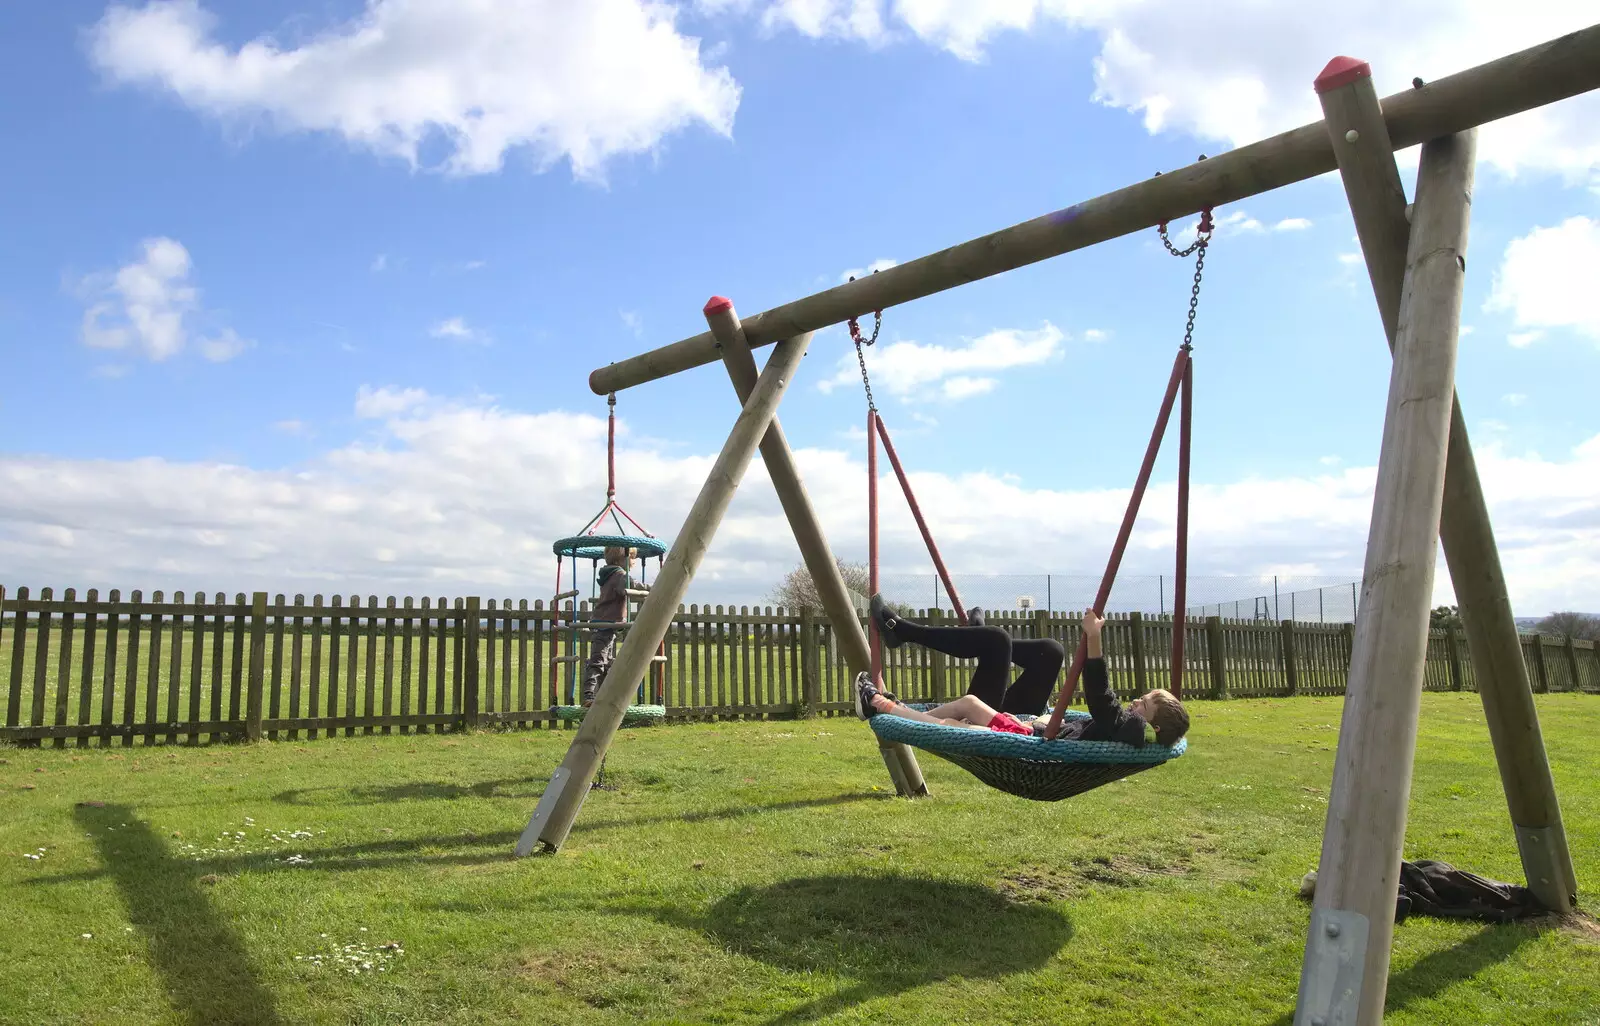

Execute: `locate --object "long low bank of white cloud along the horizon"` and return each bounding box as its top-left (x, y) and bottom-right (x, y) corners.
top-left (0, 387), bottom-right (1600, 611)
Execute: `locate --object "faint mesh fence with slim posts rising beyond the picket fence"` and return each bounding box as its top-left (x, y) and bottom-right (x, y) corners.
top-left (880, 573), bottom-right (1360, 623)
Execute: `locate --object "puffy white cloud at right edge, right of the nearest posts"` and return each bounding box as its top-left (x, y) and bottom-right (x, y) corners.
top-left (1483, 216), bottom-right (1600, 347)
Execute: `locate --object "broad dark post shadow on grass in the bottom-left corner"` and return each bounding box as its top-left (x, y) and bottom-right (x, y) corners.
top-left (74, 805), bottom-right (283, 1026)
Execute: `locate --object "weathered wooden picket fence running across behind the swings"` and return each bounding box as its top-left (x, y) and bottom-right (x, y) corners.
top-left (0, 587), bottom-right (1600, 747)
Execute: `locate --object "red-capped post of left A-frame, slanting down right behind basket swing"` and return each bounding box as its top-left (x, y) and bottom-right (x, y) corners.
top-left (704, 296), bottom-right (928, 797)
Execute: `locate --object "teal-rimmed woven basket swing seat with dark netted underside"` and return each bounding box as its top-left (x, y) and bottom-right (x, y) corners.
top-left (867, 704), bottom-right (1189, 802)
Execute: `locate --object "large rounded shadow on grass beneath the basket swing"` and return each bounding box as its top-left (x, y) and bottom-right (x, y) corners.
top-left (648, 874), bottom-right (1072, 1026)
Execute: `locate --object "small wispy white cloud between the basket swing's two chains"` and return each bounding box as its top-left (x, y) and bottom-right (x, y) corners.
top-left (818, 322), bottom-right (1066, 400)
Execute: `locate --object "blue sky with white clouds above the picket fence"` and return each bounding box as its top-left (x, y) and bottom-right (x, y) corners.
top-left (0, 0), bottom-right (1600, 615)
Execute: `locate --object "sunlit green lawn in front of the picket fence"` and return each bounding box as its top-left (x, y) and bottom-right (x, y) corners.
top-left (0, 695), bottom-right (1600, 1026)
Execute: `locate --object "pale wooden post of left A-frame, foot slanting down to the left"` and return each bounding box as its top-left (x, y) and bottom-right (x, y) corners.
top-left (517, 331), bottom-right (811, 855)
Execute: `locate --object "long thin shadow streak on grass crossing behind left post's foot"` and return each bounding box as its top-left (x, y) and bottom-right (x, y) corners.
top-left (40, 792), bottom-right (891, 885)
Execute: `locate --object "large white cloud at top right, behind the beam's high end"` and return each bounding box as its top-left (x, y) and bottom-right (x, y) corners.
top-left (732, 0), bottom-right (1600, 187)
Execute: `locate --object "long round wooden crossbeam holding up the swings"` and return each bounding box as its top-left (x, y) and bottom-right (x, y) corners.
top-left (589, 26), bottom-right (1600, 395)
